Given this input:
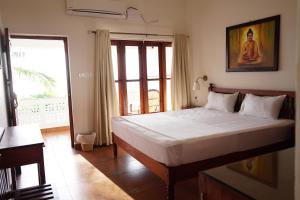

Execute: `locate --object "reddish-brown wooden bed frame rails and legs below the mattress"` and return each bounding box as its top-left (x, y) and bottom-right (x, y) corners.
top-left (112, 129), bottom-right (294, 200)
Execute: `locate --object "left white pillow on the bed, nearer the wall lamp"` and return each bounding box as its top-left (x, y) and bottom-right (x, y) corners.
top-left (205, 92), bottom-right (239, 112)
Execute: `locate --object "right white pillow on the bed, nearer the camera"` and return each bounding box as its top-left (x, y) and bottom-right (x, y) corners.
top-left (239, 94), bottom-right (286, 119)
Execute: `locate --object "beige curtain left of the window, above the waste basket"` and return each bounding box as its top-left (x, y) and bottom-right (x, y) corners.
top-left (95, 30), bottom-right (118, 145)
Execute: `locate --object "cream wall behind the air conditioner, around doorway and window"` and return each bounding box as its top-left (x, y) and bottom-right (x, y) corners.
top-left (0, 0), bottom-right (184, 136)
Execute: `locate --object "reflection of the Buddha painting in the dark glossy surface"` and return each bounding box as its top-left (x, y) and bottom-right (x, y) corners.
top-left (227, 153), bottom-right (278, 188)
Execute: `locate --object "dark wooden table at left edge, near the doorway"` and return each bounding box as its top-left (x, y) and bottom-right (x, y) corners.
top-left (0, 125), bottom-right (46, 189)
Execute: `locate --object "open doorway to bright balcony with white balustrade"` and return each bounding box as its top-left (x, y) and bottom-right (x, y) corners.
top-left (9, 35), bottom-right (74, 146)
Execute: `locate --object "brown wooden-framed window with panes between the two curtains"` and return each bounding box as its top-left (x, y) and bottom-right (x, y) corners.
top-left (111, 40), bottom-right (172, 115)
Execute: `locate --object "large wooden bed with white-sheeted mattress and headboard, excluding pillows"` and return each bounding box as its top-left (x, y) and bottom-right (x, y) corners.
top-left (112, 85), bottom-right (295, 200)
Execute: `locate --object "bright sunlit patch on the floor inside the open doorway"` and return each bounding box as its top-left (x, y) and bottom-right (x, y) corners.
top-left (18, 132), bottom-right (132, 200)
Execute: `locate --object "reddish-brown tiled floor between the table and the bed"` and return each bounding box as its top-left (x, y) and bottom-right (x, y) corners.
top-left (18, 132), bottom-right (198, 200)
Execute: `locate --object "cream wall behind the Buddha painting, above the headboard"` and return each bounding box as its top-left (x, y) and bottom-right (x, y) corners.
top-left (186, 0), bottom-right (297, 104)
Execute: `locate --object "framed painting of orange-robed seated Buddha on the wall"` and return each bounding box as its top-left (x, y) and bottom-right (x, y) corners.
top-left (226, 15), bottom-right (280, 72)
